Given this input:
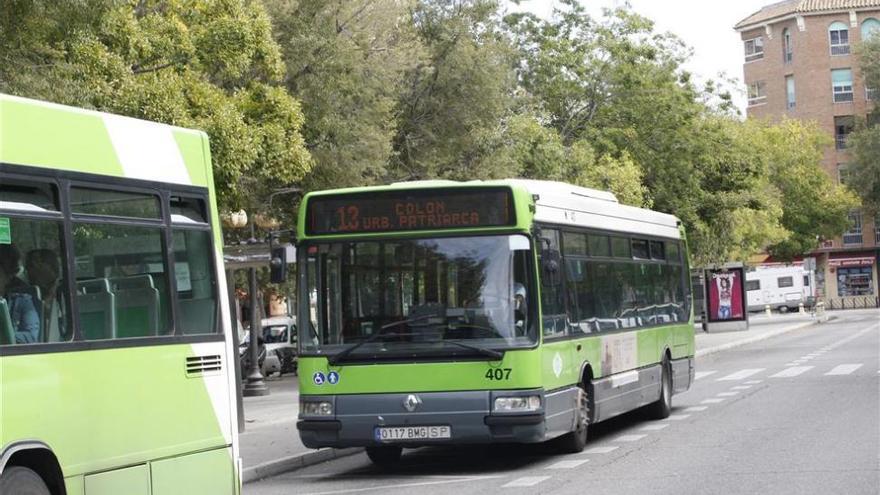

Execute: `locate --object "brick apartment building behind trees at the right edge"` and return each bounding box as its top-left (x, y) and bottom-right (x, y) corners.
top-left (734, 0), bottom-right (880, 307)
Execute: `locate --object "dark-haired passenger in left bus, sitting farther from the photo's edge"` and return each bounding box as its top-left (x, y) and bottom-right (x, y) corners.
top-left (24, 249), bottom-right (65, 342)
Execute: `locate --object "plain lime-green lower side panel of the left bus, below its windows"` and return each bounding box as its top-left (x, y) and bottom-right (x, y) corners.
top-left (0, 344), bottom-right (227, 477)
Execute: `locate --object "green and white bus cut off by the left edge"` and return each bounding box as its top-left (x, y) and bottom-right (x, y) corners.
top-left (0, 95), bottom-right (241, 495)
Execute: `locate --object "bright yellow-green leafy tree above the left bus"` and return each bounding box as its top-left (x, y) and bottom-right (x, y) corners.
top-left (0, 0), bottom-right (311, 208)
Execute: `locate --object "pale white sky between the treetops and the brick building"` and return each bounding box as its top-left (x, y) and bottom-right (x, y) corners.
top-left (508, 0), bottom-right (778, 115)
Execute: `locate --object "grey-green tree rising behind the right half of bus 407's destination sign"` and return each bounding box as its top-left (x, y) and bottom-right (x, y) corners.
top-left (388, 0), bottom-right (515, 180)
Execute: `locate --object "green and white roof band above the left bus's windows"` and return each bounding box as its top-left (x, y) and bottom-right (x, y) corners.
top-left (0, 94), bottom-right (211, 187)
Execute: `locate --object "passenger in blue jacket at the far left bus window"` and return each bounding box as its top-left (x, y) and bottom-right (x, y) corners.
top-left (0, 244), bottom-right (40, 344)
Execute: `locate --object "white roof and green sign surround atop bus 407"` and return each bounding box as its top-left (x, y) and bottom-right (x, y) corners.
top-left (299, 179), bottom-right (681, 239)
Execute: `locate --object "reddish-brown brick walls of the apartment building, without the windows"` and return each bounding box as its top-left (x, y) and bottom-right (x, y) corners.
top-left (736, 0), bottom-right (880, 304)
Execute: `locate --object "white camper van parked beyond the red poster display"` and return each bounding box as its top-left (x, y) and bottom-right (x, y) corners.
top-left (746, 265), bottom-right (815, 313)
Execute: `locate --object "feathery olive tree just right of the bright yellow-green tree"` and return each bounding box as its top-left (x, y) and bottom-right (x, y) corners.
top-left (266, 0), bottom-right (423, 189)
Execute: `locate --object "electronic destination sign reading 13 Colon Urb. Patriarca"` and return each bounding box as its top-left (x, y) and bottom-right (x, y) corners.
top-left (306, 188), bottom-right (516, 235)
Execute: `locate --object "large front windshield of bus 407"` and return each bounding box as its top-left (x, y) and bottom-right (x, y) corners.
top-left (300, 235), bottom-right (537, 360)
